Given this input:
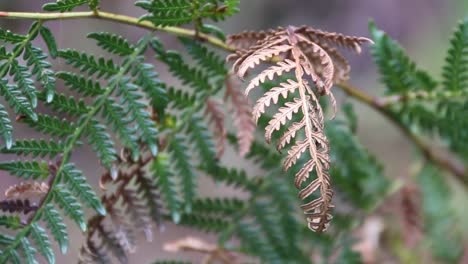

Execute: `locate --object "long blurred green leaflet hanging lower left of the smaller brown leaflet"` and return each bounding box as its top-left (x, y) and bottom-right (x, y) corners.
top-left (168, 135), bottom-right (197, 213)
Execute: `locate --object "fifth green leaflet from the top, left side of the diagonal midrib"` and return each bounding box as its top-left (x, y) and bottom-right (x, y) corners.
top-left (22, 114), bottom-right (75, 138)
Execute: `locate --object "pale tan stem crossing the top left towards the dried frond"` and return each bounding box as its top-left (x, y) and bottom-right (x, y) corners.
top-left (0, 10), bottom-right (235, 51)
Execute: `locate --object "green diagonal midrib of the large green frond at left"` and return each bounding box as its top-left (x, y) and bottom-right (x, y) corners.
top-left (0, 36), bottom-right (151, 263)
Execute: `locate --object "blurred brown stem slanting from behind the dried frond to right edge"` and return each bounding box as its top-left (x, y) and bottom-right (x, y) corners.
top-left (336, 83), bottom-right (468, 186)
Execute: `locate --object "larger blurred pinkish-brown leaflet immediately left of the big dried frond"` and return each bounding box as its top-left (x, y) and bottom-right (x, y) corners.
top-left (224, 74), bottom-right (255, 156)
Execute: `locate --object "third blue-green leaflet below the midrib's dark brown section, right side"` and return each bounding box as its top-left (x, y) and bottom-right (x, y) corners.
top-left (42, 203), bottom-right (69, 254)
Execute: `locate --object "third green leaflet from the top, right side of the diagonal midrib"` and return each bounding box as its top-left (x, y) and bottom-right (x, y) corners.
top-left (102, 98), bottom-right (139, 160)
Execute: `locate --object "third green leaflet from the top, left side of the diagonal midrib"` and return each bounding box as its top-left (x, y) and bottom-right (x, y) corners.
top-left (55, 71), bottom-right (104, 96)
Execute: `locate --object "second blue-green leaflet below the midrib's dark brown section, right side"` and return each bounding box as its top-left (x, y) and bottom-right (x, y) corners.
top-left (52, 184), bottom-right (86, 232)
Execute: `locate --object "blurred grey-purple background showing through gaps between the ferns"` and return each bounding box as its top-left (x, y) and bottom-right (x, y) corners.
top-left (0, 0), bottom-right (468, 263)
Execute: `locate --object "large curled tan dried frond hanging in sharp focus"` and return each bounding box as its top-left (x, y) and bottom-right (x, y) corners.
top-left (228, 26), bottom-right (370, 232)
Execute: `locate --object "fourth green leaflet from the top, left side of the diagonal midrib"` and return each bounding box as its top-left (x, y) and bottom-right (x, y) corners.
top-left (39, 93), bottom-right (89, 116)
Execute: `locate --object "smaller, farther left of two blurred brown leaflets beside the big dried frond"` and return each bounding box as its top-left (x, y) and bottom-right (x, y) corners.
top-left (205, 98), bottom-right (227, 158)
